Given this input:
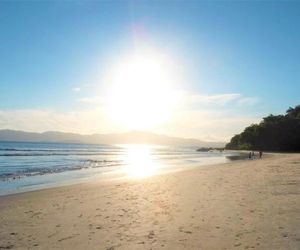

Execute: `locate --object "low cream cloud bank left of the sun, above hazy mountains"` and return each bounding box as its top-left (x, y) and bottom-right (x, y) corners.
top-left (0, 109), bottom-right (120, 134)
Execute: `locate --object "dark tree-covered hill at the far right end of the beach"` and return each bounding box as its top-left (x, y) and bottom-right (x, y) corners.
top-left (225, 105), bottom-right (300, 152)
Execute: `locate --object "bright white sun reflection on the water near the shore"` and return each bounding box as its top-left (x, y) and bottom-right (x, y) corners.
top-left (124, 145), bottom-right (159, 178)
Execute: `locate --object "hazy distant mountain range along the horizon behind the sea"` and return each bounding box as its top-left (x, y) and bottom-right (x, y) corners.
top-left (0, 129), bottom-right (225, 147)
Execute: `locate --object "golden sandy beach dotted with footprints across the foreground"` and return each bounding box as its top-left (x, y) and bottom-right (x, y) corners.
top-left (0, 154), bottom-right (300, 250)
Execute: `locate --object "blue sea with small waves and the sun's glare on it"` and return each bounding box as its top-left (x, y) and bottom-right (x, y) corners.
top-left (0, 142), bottom-right (240, 195)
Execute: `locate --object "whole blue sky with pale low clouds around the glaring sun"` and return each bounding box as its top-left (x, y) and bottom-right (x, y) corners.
top-left (0, 0), bottom-right (300, 141)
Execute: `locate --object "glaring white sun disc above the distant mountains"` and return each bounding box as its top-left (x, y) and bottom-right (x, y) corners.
top-left (107, 49), bottom-right (175, 130)
